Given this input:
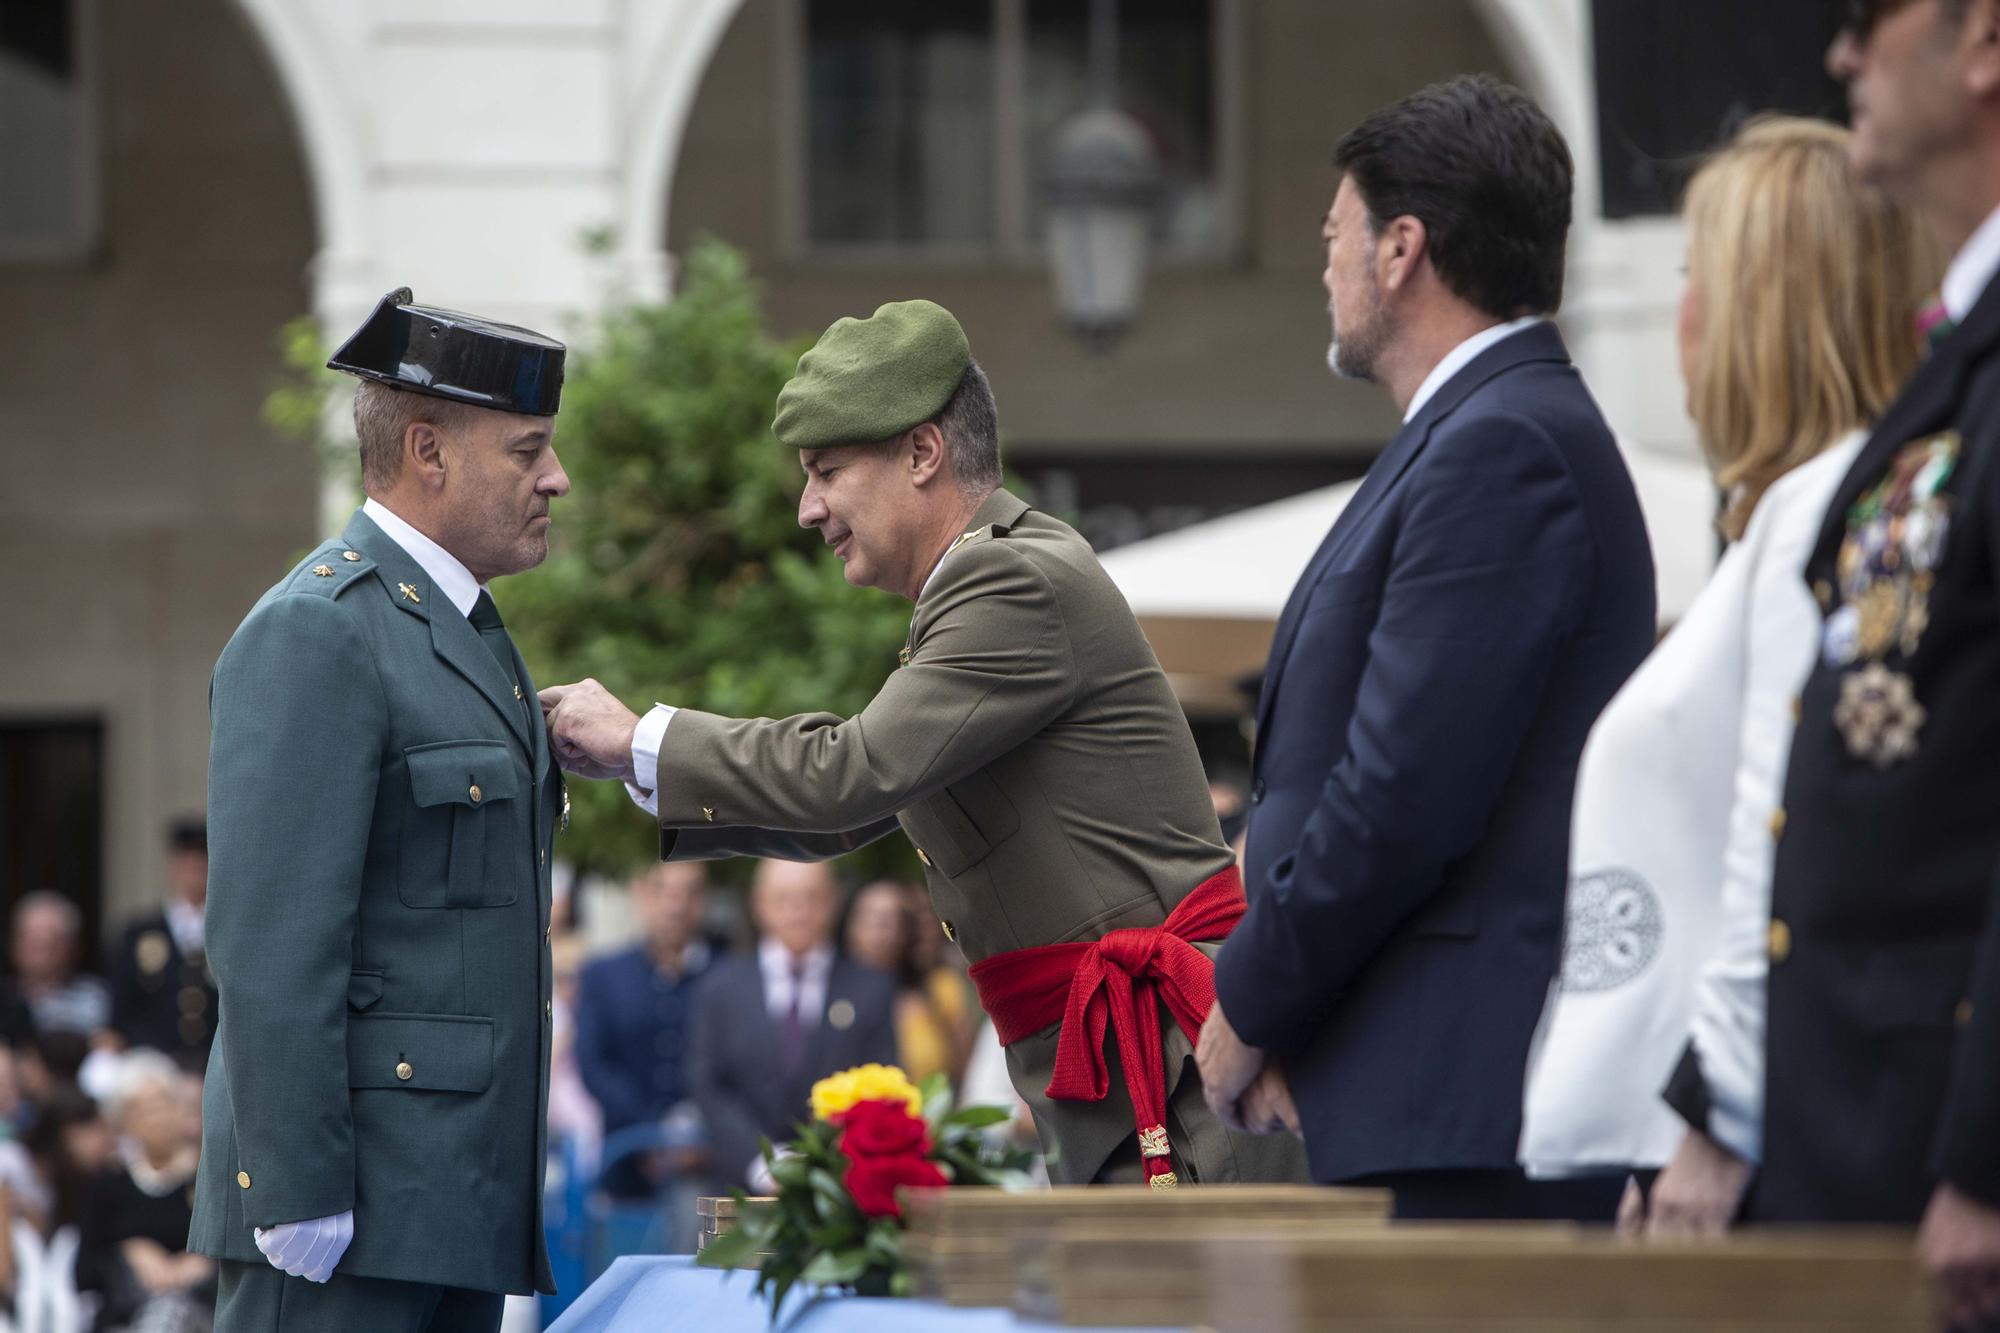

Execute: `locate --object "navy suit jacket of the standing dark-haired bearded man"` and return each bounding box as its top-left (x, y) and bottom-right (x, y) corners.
top-left (1216, 324), bottom-right (1654, 1181)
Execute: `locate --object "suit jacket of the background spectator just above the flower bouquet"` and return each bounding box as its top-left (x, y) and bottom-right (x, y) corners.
top-left (688, 953), bottom-right (896, 1189)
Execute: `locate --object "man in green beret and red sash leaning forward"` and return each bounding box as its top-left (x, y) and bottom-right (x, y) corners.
top-left (542, 300), bottom-right (1304, 1189)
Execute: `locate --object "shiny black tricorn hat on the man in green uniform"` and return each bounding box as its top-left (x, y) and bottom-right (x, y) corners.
top-left (326, 286), bottom-right (564, 416)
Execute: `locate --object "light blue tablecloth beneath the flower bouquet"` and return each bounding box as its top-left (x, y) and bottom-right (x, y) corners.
top-left (548, 1255), bottom-right (1188, 1333)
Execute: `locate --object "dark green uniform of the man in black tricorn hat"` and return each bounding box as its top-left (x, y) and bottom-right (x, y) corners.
top-left (190, 514), bottom-right (562, 1304)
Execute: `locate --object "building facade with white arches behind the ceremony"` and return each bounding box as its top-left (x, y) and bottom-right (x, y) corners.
top-left (0, 0), bottom-right (1696, 921)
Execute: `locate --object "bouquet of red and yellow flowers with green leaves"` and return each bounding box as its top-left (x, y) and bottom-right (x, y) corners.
top-left (698, 1065), bottom-right (1028, 1319)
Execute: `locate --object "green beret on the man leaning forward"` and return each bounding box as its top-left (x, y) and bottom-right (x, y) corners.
top-left (770, 300), bottom-right (972, 448)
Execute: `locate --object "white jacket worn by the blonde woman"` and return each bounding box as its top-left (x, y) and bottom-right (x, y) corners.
top-left (1520, 430), bottom-right (1866, 1177)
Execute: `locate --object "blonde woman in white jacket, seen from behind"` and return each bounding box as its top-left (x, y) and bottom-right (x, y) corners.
top-left (1522, 118), bottom-right (1938, 1229)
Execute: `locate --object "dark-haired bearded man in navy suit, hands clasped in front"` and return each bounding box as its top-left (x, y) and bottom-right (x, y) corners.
top-left (1200, 78), bottom-right (1654, 1219)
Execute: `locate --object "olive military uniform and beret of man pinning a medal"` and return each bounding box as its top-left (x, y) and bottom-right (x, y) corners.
top-left (656, 302), bottom-right (1306, 1183)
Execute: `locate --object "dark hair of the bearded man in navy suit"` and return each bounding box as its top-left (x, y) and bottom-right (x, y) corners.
top-left (1334, 74), bottom-right (1574, 318)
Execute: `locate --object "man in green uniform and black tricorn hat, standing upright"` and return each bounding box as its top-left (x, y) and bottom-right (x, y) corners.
top-left (190, 288), bottom-right (570, 1333)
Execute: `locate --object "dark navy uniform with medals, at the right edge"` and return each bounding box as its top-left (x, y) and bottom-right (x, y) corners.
top-left (1748, 282), bottom-right (2000, 1223)
